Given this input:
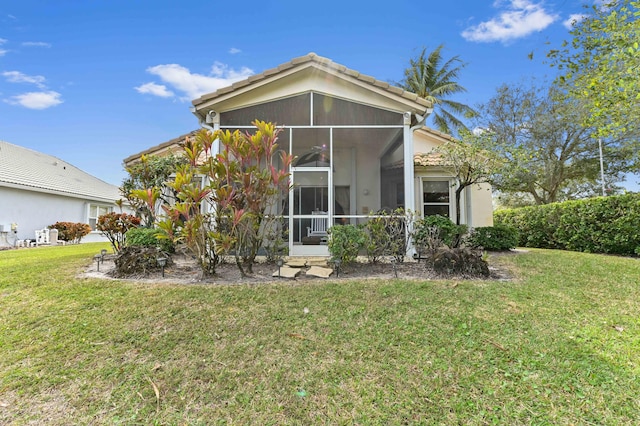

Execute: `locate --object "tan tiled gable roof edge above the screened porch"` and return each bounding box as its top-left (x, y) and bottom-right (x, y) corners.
top-left (193, 53), bottom-right (431, 108)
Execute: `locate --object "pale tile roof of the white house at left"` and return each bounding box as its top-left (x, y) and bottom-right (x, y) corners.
top-left (0, 141), bottom-right (121, 202)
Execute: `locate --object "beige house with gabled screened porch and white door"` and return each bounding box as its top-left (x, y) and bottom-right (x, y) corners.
top-left (125, 53), bottom-right (493, 255)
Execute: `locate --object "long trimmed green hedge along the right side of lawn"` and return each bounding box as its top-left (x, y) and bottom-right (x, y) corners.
top-left (494, 194), bottom-right (640, 256)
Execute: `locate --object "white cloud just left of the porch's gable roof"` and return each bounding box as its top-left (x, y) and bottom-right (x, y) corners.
top-left (141, 62), bottom-right (253, 100)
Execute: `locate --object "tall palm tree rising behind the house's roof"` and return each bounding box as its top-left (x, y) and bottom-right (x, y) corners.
top-left (399, 44), bottom-right (476, 134)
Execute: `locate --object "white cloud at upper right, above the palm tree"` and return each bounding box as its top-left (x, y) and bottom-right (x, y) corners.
top-left (462, 0), bottom-right (558, 42)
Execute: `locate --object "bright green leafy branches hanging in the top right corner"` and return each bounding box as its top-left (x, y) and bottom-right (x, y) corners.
top-left (549, 0), bottom-right (640, 136)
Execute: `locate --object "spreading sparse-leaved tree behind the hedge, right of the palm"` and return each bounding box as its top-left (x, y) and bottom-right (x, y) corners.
top-left (477, 83), bottom-right (631, 204)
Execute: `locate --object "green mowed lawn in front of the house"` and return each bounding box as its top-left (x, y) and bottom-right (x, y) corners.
top-left (0, 244), bottom-right (640, 425)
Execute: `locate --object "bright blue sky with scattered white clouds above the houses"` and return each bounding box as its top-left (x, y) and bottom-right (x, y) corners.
top-left (0, 0), bottom-right (639, 190)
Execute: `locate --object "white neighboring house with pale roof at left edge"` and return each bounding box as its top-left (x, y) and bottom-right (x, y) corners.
top-left (0, 141), bottom-right (121, 245)
